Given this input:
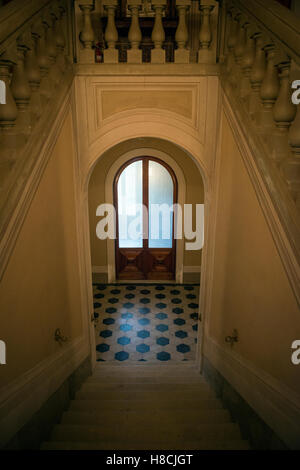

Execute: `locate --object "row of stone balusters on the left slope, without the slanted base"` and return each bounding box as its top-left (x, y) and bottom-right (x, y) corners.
top-left (0, 0), bottom-right (70, 209)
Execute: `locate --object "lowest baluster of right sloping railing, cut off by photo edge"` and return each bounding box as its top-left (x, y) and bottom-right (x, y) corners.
top-left (282, 105), bottom-right (300, 209)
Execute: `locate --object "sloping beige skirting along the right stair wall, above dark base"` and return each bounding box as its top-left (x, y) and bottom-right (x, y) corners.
top-left (204, 337), bottom-right (300, 449)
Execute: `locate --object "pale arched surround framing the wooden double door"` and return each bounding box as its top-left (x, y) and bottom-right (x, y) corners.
top-left (105, 148), bottom-right (186, 283)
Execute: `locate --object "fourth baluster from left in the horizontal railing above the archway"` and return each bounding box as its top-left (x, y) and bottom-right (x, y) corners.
top-left (151, 0), bottom-right (167, 64)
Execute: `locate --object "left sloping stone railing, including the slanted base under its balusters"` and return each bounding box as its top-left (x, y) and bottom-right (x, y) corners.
top-left (0, 0), bottom-right (73, 276)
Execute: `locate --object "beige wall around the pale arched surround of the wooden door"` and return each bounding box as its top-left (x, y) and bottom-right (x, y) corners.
top-left (89, 138), bottom-right (204, 272)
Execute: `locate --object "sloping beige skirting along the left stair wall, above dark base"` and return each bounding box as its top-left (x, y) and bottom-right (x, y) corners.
top-left (0, 337), bottom-right (90, 449)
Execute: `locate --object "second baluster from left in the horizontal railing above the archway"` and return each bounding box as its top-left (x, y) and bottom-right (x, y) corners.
top-left (103, 0), bottom-right (119, 64)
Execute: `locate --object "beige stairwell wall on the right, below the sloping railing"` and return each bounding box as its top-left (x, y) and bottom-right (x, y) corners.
top-left (209, 112), bottom-right (300, 393)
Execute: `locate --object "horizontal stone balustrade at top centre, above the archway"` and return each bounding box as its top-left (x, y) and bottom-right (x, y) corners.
top-left (75, 0), bottom-right (219, 64)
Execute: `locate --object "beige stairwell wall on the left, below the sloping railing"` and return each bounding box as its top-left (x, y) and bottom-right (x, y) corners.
top-left (0, 109), bottom-right (82, 385)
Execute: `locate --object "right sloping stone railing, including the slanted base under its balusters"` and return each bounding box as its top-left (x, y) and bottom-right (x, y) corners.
top-left (219, 0), bottom-right (300, 282)
